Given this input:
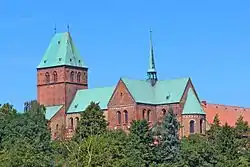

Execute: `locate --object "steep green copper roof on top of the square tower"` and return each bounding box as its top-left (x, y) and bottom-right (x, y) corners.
top-left (37, 32), bottom-right (87, 68)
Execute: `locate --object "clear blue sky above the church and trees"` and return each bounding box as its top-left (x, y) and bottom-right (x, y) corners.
top-left (0, 0), bottom-right (250, 110)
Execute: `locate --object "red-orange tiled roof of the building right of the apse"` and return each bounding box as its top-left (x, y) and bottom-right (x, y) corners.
top-left (201, 101), bottom-right (250, 126)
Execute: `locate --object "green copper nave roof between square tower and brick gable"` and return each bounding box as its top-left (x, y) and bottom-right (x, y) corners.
top-left (67, 87), bottom-right (115, 113)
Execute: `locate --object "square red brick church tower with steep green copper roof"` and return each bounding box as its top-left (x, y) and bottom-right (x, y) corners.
top-left (37, 32), bottom-right (88, 110)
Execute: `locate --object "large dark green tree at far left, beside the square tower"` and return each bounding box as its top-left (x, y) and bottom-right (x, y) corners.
top-left (0, 101), bottom-right (53, 167)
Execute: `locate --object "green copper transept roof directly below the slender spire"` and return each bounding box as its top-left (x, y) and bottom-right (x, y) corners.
top-left (121, 78), bottom-right (189, 104)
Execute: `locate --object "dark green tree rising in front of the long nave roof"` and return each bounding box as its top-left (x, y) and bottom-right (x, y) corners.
top-left (74, 102), bottom-right (107, 142)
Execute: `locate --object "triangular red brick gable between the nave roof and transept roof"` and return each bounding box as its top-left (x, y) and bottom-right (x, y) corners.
top-left (108, 80), bottom-right (135, 106)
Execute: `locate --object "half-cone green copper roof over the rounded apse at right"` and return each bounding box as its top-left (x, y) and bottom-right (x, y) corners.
top-left (182, 88), bottom-right (205, 115)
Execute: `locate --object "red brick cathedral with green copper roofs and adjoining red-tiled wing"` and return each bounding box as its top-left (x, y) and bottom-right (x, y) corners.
top-left (37, 32), bottom-right (250, 139)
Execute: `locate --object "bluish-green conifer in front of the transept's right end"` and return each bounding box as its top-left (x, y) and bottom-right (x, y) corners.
top-left (155, 108), bottom-right (180, 164)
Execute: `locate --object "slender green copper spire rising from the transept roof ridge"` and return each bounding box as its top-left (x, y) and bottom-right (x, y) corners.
top-left (147, 29), bottom-right (157, 86)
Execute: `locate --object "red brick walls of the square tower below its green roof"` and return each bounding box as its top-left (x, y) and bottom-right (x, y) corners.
top-left (37, 67), bottom-right (88, 109)
